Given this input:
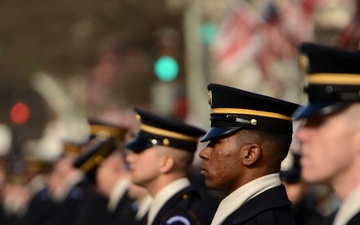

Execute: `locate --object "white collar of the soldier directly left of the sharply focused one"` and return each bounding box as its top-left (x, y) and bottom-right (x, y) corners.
top-left (147, 178), bottom-right (190, 225)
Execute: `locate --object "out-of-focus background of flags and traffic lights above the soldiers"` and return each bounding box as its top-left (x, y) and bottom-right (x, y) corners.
top-left (0, 0), bottom-right (360, 213)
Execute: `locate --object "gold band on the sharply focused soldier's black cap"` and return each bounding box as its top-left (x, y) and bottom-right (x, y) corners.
top-left (211, 108), bottom-right (291, 120)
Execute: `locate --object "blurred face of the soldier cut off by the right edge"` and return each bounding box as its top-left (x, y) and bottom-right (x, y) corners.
top-left (296, 105), bottom-right (360, 190)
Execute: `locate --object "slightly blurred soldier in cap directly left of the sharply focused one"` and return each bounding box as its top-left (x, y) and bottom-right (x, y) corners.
top-left (126, 109), bottom-right (213, 225)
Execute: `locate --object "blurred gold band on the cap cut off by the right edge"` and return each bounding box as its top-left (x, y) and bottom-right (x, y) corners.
top-left (307, 73), bottom-right (360, 85)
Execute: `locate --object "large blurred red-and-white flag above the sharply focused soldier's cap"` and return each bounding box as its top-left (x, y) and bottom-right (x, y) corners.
top-left (212, 0), bottom-right (317, 77)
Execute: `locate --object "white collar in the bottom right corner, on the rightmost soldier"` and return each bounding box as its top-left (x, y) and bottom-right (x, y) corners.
top-left (334, 185), bottom-right (360, 225)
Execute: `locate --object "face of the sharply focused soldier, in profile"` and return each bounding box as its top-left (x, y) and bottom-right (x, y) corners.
top-left (199, 132), bottom-right (243, 192)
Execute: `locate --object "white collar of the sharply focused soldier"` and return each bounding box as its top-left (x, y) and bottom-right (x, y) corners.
top-left (211, 173), bottom-right (281, 225)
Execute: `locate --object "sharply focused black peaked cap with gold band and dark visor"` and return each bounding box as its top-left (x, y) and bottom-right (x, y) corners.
top-left (201, 84), bottom-right (299, 142)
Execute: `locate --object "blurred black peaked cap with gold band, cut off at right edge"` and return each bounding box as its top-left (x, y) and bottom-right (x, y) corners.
top-left (294, 42), bottom-right (360, 119)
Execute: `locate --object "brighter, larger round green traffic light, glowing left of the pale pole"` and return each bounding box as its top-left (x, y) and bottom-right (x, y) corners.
top-left (154, 56), bottom-right (179, 81)
